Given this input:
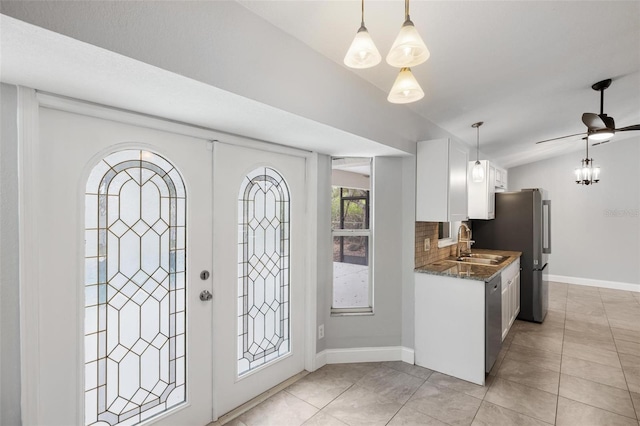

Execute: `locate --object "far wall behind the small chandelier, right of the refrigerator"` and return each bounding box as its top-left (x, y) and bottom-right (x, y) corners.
top-left (508, 136), bottom-right (640, 291)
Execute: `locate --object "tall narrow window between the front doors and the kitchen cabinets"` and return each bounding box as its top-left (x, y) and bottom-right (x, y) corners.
top-left (331, 158), bottom-right (373, 314)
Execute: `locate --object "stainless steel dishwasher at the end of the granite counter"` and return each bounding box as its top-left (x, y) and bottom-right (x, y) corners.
top-left (484, 274), bottom-right (502, 373)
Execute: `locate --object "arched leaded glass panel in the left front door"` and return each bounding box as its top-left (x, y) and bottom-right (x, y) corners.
top-left (84, 149), bottom-right (186, 425)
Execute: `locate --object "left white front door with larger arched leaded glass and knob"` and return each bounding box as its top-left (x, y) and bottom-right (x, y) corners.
top-left (27, 108), bottom-right (213, 426)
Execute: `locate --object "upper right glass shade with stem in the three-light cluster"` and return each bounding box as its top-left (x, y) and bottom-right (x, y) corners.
top-left (387, 0), bottom-right (431, 68)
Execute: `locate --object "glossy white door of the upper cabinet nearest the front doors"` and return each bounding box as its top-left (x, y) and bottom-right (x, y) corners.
top-left (449, 141), bottom-right (469, 222)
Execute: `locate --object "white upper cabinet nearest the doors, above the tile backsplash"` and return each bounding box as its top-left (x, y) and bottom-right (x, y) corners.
top-left (416, 139), bottom-right (469, 222)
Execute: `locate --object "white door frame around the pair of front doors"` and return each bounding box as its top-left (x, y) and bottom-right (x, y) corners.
top-left (17, 86), bottom-right (318, 424)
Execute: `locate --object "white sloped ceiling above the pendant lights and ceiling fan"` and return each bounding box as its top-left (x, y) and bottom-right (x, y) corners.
top-left (240, 0), bottom-right (640, 167)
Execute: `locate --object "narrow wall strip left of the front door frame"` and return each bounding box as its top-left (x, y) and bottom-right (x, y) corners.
top-left (0, 84), bottom-right (20, 425)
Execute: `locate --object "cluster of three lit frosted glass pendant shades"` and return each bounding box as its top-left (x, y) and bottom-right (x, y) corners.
top-left (344, 0), bottom-right (431, 104)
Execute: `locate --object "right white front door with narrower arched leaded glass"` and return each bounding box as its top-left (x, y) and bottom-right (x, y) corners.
top-left (213, 142), bottom-right (306, 416)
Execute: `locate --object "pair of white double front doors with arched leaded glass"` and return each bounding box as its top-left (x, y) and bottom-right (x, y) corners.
top-left (22, 99), bottom-right (307, 426)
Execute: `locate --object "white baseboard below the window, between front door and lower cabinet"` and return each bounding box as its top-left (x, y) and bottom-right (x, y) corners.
top-left (316, 346), bottom-right (414, 368)
